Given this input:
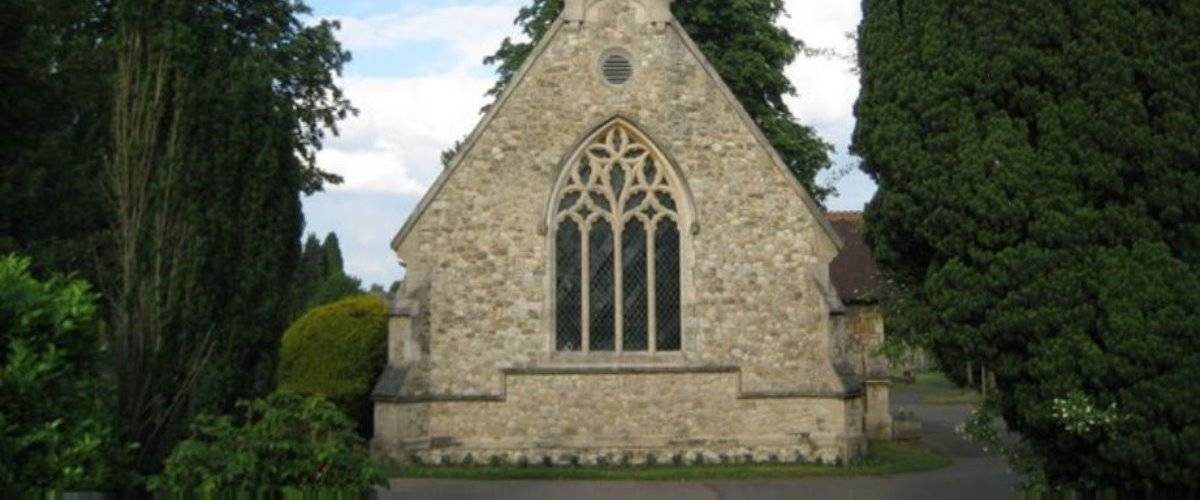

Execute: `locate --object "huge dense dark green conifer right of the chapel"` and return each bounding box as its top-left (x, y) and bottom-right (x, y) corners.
top-left (854, 0), bottom-right (1200, 487)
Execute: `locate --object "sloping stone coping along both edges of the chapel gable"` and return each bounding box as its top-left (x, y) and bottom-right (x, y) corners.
top-left (391, 2), bottom-right (842, 252)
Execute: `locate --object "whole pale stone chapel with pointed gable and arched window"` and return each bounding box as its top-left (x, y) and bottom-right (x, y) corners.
top-left (372, 0), bottom-right (890, 464)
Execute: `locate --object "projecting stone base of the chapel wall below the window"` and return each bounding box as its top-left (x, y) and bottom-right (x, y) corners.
top-left (372, 368), bottom-right (866, 464)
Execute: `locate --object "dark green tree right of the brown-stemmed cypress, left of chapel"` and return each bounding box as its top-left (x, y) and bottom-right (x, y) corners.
top-left (176, 1), bottom-right (349, 417)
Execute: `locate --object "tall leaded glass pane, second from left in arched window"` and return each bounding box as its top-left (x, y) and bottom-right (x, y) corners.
top-left (588, 218), bottom-right (617, 350)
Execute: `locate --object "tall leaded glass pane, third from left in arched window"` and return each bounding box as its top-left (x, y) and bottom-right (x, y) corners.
top-left (620, 218), bottom-right (649, 350)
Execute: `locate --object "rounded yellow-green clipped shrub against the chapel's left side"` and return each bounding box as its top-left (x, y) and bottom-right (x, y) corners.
top-left (278, 295), bottom-right (388, 434)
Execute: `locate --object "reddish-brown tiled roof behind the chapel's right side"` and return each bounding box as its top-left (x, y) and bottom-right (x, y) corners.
top-left (826, 212), bottom-right (880, 305)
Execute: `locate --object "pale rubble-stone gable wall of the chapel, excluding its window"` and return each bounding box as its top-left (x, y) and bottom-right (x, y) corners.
top-left (377, 0), bottom-right (860, 457)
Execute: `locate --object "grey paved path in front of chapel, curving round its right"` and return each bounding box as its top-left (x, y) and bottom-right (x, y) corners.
top-left (379, 393), bottom-right (1016, 500)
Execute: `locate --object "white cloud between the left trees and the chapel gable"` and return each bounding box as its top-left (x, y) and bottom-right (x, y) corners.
top-left (318, 0), bottom-right (520, 197)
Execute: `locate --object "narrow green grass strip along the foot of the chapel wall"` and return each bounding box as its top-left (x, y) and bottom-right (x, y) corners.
top-left (386, 441), bottom-right (950, 481)
